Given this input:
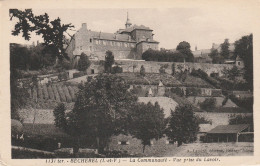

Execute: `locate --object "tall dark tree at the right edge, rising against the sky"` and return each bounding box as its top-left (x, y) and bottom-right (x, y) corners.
top-left (235, 34), bottom-right (253, 90)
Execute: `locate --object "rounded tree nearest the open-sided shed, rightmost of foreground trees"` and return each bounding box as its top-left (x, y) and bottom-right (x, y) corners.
top-left (166, 105), bottom-right (199, 146)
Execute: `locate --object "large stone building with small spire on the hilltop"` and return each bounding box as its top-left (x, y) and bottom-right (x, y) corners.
top-left (66, 12), bottom-right (159, 63)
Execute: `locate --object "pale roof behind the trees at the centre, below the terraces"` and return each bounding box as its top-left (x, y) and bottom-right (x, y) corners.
top-left (138, 97), bottom-right (178, 118)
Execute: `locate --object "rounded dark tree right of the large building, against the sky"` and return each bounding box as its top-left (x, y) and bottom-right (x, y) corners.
top-left (176, 41), bottom-right (194, 62)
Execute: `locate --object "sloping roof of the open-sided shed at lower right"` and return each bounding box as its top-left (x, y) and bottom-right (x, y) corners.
top-left (208, 124), bottom-right (249, 134)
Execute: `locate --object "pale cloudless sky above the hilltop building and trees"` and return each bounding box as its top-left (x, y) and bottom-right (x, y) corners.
top-left (10, 7), bottom-right (255, 50)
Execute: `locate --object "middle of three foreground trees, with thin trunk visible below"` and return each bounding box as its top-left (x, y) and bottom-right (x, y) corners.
top-left (130, 102), bottom-right (165, 153)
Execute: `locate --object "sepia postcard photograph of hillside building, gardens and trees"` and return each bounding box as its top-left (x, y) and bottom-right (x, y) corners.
top-left (1, 0), bottom-right (255, 162)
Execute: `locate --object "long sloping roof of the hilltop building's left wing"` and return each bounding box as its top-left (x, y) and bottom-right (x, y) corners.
top-left (89, 31), bottom-right (135, 42)
